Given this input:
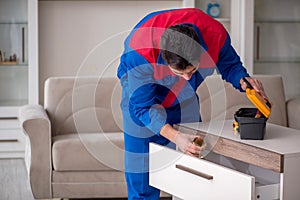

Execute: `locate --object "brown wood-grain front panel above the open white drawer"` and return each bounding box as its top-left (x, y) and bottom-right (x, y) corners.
top-left (174, 125), bottom-right (284, 173)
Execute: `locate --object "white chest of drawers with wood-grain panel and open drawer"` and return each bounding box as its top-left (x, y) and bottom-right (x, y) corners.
top-left (150, 120), bottom-right (300, 200)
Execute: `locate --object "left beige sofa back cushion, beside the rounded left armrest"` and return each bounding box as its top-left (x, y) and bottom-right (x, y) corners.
top-left (44, 77), bottom-right (123, 136)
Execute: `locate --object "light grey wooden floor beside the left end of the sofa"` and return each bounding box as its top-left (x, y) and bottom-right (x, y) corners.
top-left (0, 158), bottom-right (172, 200)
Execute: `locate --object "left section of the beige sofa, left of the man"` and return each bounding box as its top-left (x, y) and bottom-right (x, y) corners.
top-left (19, 77), bottom-right (127, 199)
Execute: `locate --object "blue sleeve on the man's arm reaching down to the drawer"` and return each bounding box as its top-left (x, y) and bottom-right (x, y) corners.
top-left (119, 50), bottom-right (167, 135)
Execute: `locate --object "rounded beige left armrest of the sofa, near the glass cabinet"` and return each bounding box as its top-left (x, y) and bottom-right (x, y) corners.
top-left (19, 105), bottom-right (52, 199)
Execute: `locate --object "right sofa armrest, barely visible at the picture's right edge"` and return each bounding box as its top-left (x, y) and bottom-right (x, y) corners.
top-left (286, 96), bottom-right (300, 130)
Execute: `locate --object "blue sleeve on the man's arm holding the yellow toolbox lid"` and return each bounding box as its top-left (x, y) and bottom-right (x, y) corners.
top-left (217, 34), bottom-right (249, 91)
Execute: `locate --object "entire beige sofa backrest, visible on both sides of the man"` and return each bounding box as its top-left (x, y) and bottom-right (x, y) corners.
top-left (44, 75), bottom-right (287, 136)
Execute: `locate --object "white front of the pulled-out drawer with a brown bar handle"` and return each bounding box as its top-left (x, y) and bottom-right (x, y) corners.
top-left (150, 143), bottom-right (255, 200)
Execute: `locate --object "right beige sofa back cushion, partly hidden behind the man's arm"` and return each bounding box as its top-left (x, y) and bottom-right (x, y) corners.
top-left (197, 75), bottom-right (287, 126)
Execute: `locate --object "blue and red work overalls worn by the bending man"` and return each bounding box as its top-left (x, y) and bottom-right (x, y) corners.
top-left (118, 8), bottom-right (249, 200)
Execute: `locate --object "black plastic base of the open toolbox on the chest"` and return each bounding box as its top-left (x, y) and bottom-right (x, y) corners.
top-left (234, 108), bottom-right (268, 140)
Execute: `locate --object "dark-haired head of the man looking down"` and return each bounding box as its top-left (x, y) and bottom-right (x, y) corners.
top-left (160, 25), bottom-right (201, 80)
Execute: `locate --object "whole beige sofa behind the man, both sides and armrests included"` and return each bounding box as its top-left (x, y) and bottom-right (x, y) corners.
top-left (20, 76), bottom-right (300, 199)
